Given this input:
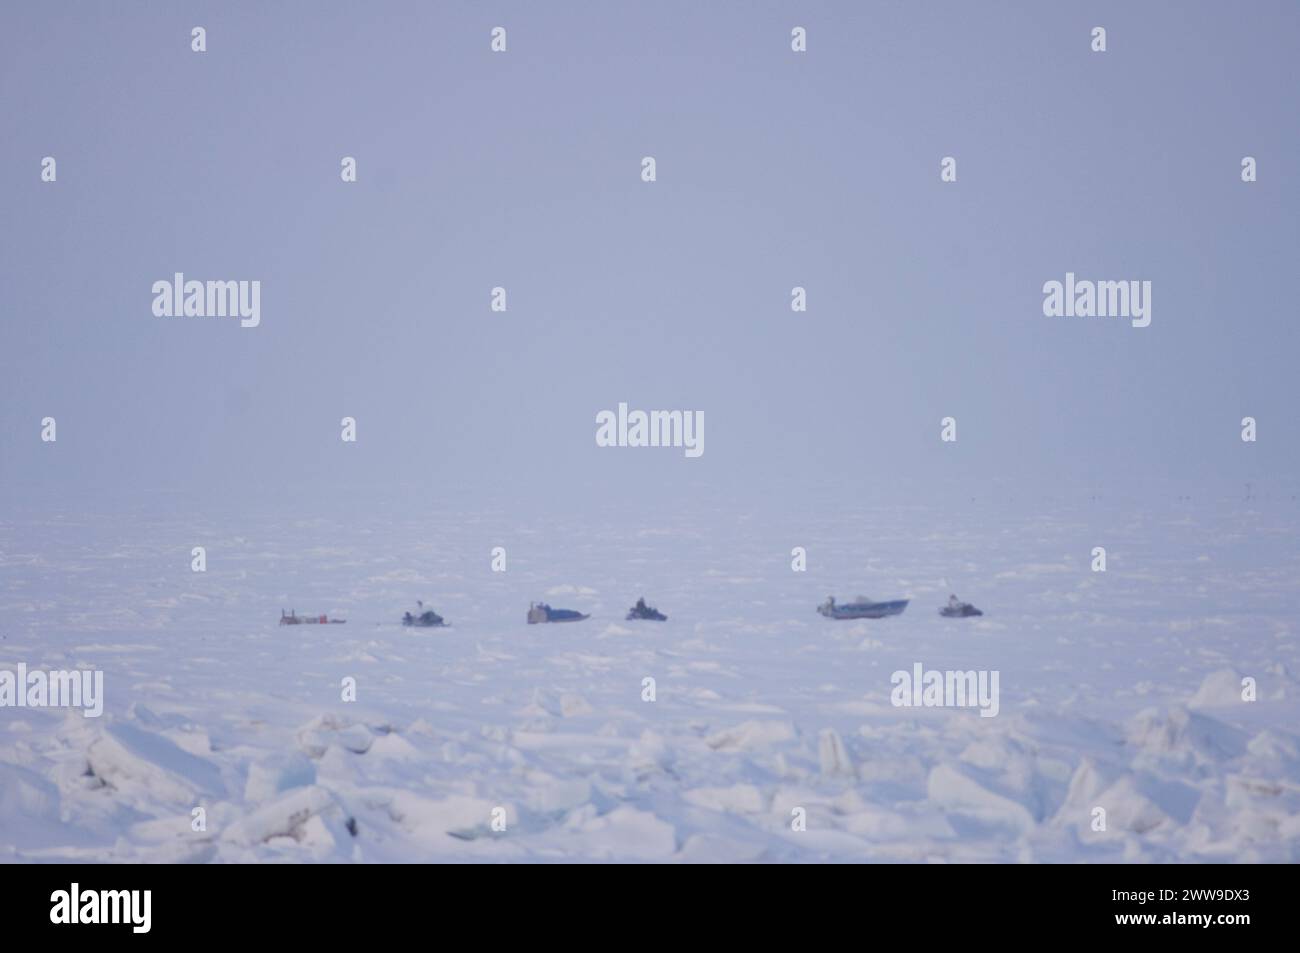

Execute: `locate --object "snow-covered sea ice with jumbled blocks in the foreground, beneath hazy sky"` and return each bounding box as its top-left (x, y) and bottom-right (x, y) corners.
top-left (0, 491), bottom-right (1300, 862)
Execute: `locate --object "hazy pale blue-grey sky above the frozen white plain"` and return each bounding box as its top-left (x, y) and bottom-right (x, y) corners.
top-left (0, 0), bottom-right (1300, 506)
